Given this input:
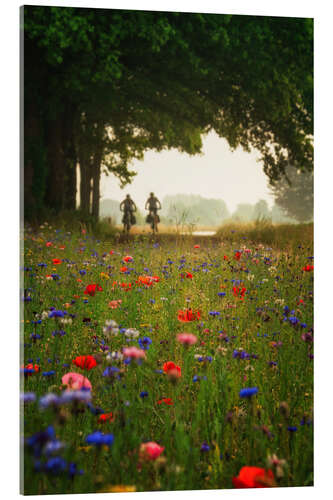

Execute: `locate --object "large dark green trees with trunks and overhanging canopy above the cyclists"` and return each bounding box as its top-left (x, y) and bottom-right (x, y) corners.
top-left (21, 5), bottom-right (313, 219)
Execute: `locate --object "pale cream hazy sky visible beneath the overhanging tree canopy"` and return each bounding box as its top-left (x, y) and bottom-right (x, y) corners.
top-left (101, 133), bottom-right (274, 211)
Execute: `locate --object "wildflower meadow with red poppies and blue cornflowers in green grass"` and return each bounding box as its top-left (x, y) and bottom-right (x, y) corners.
top-left (21, 224), bottom-right (314, 494)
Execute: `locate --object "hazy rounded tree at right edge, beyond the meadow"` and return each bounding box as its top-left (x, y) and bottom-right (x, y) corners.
top-left (271, 167), bottom-right (313, 222)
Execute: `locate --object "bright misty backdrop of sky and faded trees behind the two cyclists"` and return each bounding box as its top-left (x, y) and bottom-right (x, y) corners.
top-left (100, 132), bottom-right (313, 226)
